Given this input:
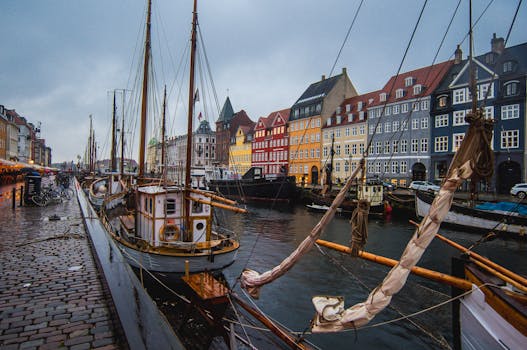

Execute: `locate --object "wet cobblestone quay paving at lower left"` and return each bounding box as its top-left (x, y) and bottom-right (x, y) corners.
top-left (0, 189), bottom-right (121, 350)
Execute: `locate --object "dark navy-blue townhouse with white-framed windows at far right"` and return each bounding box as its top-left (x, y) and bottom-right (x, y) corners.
top-left (431, 34), bottom-right (527, 193)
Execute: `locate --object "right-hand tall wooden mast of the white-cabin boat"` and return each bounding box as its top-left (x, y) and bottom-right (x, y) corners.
top-left (185, 0), bottom-right (198, 237)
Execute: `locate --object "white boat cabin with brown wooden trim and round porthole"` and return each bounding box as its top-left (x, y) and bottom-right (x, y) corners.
top-left (136, 186), bottom-right (212, 246)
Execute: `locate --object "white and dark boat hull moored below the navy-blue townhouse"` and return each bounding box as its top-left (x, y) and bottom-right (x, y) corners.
top-left (415, 191), bottom-right (527, 236)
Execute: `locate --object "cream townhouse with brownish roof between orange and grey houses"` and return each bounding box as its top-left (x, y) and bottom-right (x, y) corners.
top-left (322, 91), bottom-right (379, 183)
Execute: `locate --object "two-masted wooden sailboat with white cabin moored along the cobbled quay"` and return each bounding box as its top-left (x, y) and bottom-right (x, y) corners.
top-left (96, 0), bottom-right (243, 273)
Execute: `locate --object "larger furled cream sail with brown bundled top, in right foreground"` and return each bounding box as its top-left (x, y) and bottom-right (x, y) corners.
top-left (312, 110), bottom-right (493, 332)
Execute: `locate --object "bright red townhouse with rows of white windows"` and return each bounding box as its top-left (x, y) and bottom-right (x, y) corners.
top-left (251, 109), bottom-right (290, 175)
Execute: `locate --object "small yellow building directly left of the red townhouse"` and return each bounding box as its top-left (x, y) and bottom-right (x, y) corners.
top-left (229, 125), bottom-right (254, 175)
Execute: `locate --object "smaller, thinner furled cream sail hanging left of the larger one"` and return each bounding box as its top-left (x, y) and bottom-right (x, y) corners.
top-left (241, 158), bottom-right (365, 298)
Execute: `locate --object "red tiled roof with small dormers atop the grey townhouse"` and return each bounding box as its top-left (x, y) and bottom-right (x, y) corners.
top-left (377, 60), bottom-right (454, 105)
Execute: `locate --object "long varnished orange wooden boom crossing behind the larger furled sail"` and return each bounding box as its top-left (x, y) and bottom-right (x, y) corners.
top-left (317, 239), bottom-right (472, 290)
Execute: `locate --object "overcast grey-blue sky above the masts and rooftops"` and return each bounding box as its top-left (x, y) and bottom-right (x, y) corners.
top-left (0, 0), bottom-right (527, 162)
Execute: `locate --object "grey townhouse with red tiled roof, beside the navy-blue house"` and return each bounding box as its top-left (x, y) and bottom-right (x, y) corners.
top-left (367, 61), bottom-right (453, 187)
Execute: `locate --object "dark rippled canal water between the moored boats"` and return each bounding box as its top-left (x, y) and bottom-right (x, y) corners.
top-left (210, 206), bottom-right (527, 349)
